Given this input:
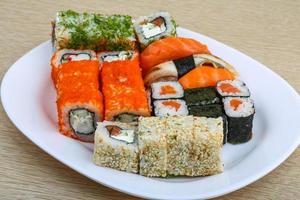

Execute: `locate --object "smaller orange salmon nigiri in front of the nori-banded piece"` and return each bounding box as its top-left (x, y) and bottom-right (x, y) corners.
top-left (179, 65), bottom-right (236, 89)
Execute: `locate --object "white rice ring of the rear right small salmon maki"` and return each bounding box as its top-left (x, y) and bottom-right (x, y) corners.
top-left (217, 79), bottom-right (250, 97)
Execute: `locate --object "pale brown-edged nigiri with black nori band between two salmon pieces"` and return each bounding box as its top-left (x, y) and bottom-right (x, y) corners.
top-left (144, 54), bottom-right (238, 85)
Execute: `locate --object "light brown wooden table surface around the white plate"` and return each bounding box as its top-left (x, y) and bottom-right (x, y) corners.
top-left (0, 0), bottom-right (300, 200)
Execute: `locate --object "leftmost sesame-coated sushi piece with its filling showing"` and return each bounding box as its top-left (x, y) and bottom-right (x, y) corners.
top-left (93, 121), bottom-right (139, 173)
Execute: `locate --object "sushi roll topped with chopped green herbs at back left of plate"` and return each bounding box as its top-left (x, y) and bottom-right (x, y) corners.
top-left (55, 10), bottom-right (135, 51)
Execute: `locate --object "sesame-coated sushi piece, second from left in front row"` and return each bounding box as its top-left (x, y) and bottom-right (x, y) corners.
top-left (138, 117), bottom-right (167, 177)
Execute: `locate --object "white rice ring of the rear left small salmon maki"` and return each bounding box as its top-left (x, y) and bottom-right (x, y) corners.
top-left (151, 81), bottom-right (183, 99)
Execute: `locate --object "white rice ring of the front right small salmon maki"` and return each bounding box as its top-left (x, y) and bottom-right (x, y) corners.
top-left (223, 97), bottom-right (254, 117)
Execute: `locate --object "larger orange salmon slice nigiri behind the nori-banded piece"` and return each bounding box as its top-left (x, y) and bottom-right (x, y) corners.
top-left (140, 37), bottom-right (210, 75)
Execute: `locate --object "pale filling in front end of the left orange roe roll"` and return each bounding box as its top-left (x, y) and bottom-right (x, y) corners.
top-left (69, 108), bottom-right (96, 135)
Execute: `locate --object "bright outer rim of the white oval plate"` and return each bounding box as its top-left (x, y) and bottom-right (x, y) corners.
top-left (0, 27), bottom-right (300, 199)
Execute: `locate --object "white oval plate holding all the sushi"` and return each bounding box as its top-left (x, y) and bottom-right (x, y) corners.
top-left (1, 28), bottom-right (300, 199)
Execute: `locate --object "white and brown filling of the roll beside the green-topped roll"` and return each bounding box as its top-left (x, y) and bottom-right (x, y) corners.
top-left (141, 17), bottom-right (167, 39)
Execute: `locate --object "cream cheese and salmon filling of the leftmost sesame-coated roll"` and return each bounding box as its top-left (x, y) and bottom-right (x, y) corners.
top-left (106, 125), bottom-right (134, 143)
